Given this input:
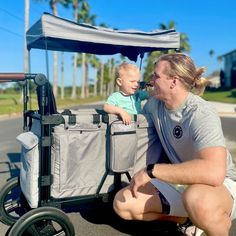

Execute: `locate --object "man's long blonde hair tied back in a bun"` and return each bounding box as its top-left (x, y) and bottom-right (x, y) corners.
top-left (156, 53), bottom-right (211, 96)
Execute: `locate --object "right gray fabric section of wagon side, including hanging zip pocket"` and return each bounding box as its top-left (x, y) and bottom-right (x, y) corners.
top-left (107, 114), bottom-right (161, 175)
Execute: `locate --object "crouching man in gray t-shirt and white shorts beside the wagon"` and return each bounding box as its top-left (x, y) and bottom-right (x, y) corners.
top-left (114, 53), bottom-right (236, 236)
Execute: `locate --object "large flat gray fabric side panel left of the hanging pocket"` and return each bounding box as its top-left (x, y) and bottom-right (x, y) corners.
top-left (51, 109), bottom-right (110, 198)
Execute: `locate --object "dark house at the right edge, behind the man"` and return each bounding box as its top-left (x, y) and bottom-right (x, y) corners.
top-left (218, 49), bottom-right (236, 88)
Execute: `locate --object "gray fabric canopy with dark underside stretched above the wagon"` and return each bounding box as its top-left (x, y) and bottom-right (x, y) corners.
top-left (26, 13), bottom-right (180, 61)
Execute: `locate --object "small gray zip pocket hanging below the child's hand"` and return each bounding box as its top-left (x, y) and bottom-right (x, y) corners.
top-left (110, 122), bottom-right (138, 173)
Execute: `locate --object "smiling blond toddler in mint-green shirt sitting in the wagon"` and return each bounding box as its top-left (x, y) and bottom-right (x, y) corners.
top-left (104, 62), bottom-right (149, 125)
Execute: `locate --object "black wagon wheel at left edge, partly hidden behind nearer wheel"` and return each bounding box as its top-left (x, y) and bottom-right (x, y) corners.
top-left (0, 177), bottom-right (24, 225)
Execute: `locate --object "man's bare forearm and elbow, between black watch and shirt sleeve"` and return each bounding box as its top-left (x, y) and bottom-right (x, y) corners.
top-left (152, 148), bottom-right (226, 186)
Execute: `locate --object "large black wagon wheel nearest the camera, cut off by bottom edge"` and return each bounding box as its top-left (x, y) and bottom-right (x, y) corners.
top-left (8, 207), bottom-right (75, 236)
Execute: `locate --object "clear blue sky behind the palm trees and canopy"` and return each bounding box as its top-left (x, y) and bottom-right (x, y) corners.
top-left (0, 0), bottom-right (236, 85)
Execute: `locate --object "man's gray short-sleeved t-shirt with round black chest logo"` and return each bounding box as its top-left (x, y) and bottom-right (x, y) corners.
top-left (144, 93), bottom-right (236, 180)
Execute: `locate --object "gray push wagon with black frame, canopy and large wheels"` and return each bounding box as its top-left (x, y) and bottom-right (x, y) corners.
top-left (0, 13), bottom-right (179, 236)
